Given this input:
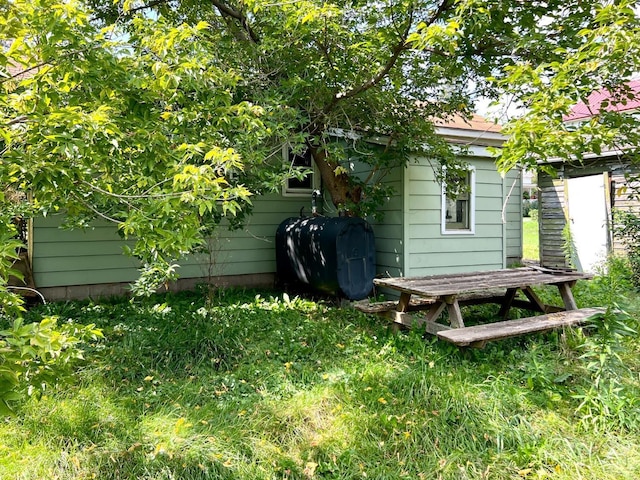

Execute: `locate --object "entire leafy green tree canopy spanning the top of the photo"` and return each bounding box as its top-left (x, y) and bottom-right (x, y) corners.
top-left (0, 0), bottom-right (638, 292)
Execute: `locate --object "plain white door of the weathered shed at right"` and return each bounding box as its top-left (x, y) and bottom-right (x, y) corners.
top-left (567, 174), bottom-right (608, 273)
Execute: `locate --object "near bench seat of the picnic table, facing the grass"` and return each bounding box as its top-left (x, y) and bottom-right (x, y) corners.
top-left (436, 308), bottom-right (604, 347)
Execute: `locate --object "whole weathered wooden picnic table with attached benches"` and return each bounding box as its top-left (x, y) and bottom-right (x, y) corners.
top-left (374, 267), bottom-right (602, 346)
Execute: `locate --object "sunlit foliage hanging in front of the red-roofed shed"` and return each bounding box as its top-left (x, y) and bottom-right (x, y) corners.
top-left (495, 0), bottom-right (640, 174)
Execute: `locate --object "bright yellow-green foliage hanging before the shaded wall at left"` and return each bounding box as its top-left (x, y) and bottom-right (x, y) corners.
top-left (1, 1), bottom-right (282, 288)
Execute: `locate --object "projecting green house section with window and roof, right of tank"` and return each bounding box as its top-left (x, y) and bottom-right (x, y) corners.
top-left (374, 117), bottom-right (522, 284)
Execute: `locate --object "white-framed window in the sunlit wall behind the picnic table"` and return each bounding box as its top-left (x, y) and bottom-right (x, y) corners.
top-left (442, 168), bottom-right (476, 234)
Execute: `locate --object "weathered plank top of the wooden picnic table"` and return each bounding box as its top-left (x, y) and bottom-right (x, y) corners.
top-left (374, 267), bottom-right (593, 297)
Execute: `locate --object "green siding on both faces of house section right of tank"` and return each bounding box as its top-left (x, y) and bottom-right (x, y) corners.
top-left (370, 151), bottom-right (522, 282)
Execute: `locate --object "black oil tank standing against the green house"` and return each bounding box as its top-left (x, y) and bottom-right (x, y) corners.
top-left (276, 217), bottom-right (376, 300)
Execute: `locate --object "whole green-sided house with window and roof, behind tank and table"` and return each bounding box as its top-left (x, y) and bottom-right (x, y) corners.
top-left (29, 117), bottom-right (522, 299)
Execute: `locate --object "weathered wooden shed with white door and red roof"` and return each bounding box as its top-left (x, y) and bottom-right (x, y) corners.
top-left (538, 81), bottom-right (640, 272)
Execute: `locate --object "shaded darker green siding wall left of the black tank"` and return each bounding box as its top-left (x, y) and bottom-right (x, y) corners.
top-left (31, 195), bottom-right (311, 288)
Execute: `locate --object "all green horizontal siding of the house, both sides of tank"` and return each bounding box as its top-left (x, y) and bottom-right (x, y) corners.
top-left (31, 150), bottom-right (522, 287)
